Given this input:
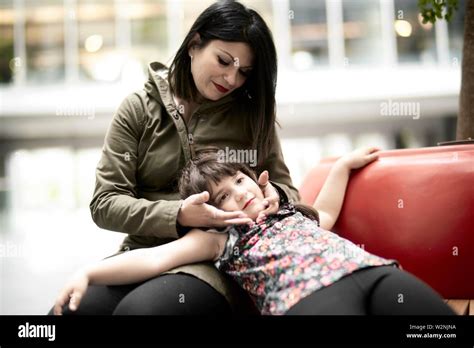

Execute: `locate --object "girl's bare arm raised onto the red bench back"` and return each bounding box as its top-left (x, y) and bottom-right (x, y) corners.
top-left (313, 147), bottom-right (378, 230)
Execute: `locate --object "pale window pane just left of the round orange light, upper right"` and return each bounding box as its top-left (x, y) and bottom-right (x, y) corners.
top-left (342, 0), bottom-right (383, 65)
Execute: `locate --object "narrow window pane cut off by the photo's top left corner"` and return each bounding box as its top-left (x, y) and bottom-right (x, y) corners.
top-left (0, 1), bottom-right (14, 83)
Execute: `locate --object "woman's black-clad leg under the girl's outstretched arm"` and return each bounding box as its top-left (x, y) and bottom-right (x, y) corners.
top-left (48, 273), bottom-right (232, 317)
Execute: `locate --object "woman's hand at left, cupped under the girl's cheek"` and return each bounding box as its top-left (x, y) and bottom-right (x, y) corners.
top-left (178, 191), bottom-right (253, 227)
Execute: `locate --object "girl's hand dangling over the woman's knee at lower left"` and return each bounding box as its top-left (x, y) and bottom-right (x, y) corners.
top-left (54, 272), bottom-right (89, 315)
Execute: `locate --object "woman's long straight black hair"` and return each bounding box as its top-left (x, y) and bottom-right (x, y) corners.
top-left (168, 0), bottom-right (277, 163)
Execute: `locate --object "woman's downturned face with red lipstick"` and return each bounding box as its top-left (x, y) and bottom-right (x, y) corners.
top-left (189, 40), bottom-right (253, 101)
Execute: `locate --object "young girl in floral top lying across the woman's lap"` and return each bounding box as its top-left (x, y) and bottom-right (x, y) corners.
top-left (54, 148), bottom-right (453, 315)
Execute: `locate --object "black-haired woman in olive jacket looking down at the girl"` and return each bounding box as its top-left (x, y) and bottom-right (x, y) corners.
top-left (50, 1), bottom-right (299, 316)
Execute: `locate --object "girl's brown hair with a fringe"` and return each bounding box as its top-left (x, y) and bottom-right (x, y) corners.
top-left (179, 152), bottom-right (319, 224)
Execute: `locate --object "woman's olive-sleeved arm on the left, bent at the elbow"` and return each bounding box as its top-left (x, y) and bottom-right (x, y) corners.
top-left (90, 93), bottom-right (182, 238)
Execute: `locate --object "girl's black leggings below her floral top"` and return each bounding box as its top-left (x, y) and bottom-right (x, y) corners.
top-left (286, 266), bottom-right (455, 315)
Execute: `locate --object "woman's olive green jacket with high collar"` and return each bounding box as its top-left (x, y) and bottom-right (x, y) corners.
top-left (90, 62), bottom-right (299, 314)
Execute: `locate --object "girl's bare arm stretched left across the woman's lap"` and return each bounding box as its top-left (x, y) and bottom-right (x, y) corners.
top-left (54, 229), bottom-right (227, 314)
